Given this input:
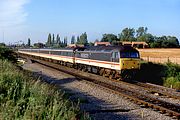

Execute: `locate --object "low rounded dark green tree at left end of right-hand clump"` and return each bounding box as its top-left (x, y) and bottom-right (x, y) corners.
top-left (101, 34), bottom-right (118, 43)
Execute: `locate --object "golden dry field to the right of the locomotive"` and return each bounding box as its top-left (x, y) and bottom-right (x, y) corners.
top-left (138, 48), bottom-right (180, 64)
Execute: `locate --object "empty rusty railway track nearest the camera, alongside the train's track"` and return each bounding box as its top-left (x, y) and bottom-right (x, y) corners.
top-left (20, 54), bottom-right (180, 119)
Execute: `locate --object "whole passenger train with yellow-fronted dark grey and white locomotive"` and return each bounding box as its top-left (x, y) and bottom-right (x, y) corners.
top-left (18, 46), bottom-right (140, 80)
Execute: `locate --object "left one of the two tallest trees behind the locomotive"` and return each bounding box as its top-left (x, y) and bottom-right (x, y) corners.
top-left (118, 28), bottom-right (136, 41)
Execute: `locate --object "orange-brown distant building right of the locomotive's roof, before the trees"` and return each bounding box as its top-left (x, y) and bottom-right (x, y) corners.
top-left (122, 42), bottom-right (149, 48)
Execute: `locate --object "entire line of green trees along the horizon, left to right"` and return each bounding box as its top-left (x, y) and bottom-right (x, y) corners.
top-left (24, 27), bottom-right (179, 48)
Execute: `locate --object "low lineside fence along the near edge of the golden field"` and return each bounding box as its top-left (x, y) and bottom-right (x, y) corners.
top-left (141, 57), bottom-right (180, 64)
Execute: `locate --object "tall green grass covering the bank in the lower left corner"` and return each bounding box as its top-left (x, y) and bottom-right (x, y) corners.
top-left (0, 60), bottom-right (89, 120)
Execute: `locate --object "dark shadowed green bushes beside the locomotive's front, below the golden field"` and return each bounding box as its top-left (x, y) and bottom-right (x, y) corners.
top-left (136, 62), bottom-right (180, 89)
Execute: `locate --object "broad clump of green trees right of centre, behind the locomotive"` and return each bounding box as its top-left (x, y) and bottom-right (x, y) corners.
top-left (101, 27), bottom-right (179, 48)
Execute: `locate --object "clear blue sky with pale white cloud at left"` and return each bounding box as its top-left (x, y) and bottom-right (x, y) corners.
top-left (0, 0), bottom-right (180, 44)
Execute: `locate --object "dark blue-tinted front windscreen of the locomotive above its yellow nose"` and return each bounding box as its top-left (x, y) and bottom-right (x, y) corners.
top-left (120, 52), bottom-right (139, 58)
